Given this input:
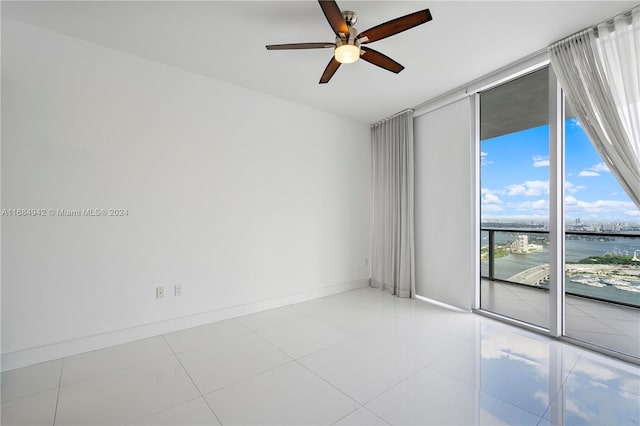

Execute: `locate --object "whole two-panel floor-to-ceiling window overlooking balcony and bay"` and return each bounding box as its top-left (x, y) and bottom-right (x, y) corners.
top-left (478, 67), bottom-right (640, 359)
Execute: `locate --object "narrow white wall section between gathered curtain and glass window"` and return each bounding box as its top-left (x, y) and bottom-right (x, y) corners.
top-left (414, 98), bottom-right (477, 310)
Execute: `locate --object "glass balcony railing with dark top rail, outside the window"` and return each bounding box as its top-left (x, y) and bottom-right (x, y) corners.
top-left (480, 228), bottom-right (640, 307)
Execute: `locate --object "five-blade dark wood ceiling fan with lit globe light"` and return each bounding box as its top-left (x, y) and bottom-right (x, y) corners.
top-left (266, 0), bottom-right (432, 84)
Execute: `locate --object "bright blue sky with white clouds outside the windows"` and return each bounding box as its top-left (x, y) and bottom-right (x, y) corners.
top-left (480, 118), bottom-right (640, 223)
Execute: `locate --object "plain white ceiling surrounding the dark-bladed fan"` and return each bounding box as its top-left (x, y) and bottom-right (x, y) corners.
top-left (2, 0), bottom-right (637, 122)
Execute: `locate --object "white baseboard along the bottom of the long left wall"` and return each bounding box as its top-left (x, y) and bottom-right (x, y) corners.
top-left (0, 278), bottom-right (369, 371)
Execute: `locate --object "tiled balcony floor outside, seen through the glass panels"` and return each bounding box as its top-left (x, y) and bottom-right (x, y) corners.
top-left (480, 280), bottom-right (640, 358)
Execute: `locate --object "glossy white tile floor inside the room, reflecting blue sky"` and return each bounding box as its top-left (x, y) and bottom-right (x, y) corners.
top-left (2, 288), bottom-right (640, 425)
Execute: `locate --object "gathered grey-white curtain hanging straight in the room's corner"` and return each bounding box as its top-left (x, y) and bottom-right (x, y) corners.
top-left (371, 111), bottom-right (415, 297)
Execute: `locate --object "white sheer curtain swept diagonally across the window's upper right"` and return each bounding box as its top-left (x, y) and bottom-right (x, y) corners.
top-left (548, 6), bottom-right (640, 208)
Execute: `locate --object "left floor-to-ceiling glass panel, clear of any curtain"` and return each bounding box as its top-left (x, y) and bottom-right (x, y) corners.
top-left (480, 68), bottom-right (549, 328)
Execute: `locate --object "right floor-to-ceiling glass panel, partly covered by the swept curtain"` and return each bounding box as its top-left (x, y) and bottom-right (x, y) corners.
top-left (564, 115), bottom-right (640, 358)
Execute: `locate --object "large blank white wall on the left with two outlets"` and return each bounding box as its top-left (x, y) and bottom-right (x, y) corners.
top-left (2, 19), bottom-right (370, 369)
